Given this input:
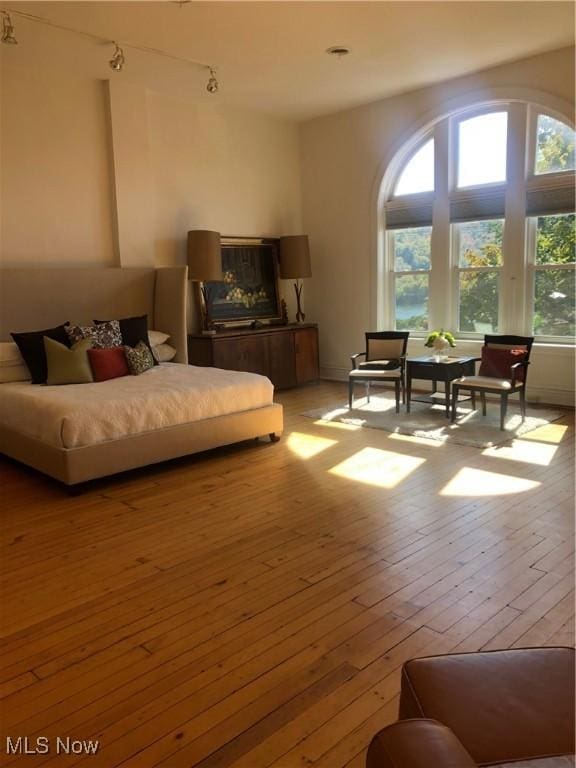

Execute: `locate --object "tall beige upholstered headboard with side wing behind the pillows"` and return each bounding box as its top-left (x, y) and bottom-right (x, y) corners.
top-left (0, 267), bottom-right (188, 363)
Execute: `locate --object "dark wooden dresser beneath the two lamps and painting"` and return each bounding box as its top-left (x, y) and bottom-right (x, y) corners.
top-left (188, 323), bottom-right (320, 389)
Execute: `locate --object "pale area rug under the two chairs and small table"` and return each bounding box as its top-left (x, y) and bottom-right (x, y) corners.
top-left (303, 395), bottom-right (562, 448)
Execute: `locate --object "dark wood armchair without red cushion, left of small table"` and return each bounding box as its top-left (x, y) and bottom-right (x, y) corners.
top-left (348, 331), bottom-right (410, 413)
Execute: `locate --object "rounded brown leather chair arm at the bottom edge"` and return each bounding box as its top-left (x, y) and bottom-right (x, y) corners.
top-left (366, 719), bottom-right (477, 768)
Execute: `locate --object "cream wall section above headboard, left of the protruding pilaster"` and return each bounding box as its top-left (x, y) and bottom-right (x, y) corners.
top-left (0, 63), bottom-right (116, 266)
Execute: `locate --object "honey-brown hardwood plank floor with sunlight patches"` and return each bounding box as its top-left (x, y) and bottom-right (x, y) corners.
top-left (0, 383), bottom-right (574, 768)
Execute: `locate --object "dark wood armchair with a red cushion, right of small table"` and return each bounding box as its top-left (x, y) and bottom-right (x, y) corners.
top-left (452, 336), bottom-right (534, 429)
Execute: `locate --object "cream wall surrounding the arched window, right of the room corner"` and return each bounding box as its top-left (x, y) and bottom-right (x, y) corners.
top-left (300, 48), bottom-right (574, 403)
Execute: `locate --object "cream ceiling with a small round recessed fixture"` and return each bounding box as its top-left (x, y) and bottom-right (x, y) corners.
top-left (2, 0), bottom-right (574, 120)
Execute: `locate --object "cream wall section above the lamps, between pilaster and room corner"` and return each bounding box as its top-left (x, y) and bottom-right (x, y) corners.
top-left (147, 92), bottom-right (301, 265)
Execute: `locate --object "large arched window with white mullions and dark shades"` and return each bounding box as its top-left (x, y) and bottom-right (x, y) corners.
top-left (380, 102), bottom-right (576, 341)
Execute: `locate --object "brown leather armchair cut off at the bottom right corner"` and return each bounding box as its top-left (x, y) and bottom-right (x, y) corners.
top-left (366, 647), bottom-right (575, 768)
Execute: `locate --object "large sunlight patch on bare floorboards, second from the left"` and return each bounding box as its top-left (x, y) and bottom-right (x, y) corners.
top-left (328, 448), bottom-right (426, 488)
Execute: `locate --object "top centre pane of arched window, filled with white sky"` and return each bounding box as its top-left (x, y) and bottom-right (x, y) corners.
top-left (458, 112), bottom-right (508, 187)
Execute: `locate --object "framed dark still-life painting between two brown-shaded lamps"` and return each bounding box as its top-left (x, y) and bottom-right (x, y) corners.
top-left (203, 237), bottom-right (281, 325)
